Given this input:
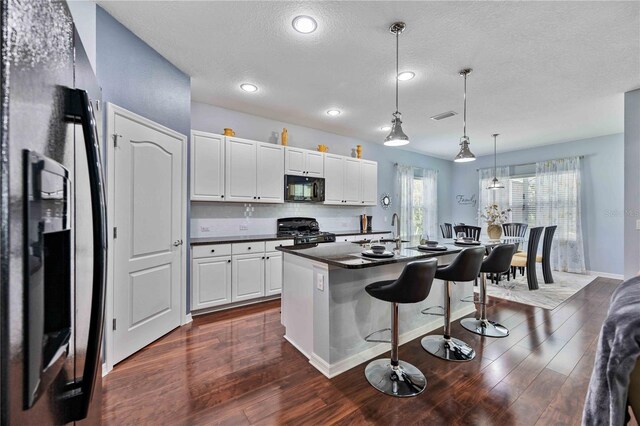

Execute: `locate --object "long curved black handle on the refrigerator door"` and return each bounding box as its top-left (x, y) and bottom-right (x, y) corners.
top-left (65, 89), bottom-right (107, 422)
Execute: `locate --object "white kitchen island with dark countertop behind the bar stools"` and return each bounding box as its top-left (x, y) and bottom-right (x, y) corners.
top-left (277, 243), bottom-right (475, 378)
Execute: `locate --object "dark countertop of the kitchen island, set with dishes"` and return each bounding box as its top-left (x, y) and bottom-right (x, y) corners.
top-left (276, 242), bottom-right (463, 269)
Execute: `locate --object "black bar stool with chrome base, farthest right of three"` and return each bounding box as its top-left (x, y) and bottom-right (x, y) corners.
top-left (460, 244), bottom-right (517, 337)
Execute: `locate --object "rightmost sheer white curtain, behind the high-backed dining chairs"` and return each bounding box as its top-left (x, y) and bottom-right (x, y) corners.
top-left (536, 157), bottom-right (586, 274)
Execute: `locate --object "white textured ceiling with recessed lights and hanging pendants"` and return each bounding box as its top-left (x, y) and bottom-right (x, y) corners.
top-left (98, 0), bottom-right (640, 158)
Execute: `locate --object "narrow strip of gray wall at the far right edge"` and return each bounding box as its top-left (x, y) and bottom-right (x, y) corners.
top-left (624, 89), bottom-right (640, 279)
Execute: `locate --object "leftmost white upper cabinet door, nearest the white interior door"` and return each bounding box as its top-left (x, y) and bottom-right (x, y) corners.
top-left (191, 130), bottom-right (225, 201)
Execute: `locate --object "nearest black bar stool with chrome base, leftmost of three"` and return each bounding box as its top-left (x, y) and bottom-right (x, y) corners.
top-left (364, 259), bottom-right (438, 397)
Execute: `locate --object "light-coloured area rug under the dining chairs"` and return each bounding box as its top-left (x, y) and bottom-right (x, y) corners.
top-left (474, 265), bottom-right (597, 309)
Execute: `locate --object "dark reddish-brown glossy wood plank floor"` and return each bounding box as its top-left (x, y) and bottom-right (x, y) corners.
top-left (102, 278), bottom-right (632, 425)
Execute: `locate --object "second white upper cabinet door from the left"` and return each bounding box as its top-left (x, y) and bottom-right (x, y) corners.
top-left (225, 137), bottom-right (258, 202)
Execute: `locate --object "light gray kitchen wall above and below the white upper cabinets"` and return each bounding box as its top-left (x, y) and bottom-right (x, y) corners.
top-left (191, 102), bottom-right (452, 236)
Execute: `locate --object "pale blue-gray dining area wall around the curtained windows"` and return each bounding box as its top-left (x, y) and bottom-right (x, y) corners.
top-left (449, 132), bottom-right (624, 274)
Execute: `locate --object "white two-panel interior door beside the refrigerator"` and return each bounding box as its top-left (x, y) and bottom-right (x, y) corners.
top-left (112, 113), bottom-right (186, 363)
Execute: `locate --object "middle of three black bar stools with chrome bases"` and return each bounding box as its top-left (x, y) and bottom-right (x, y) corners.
top-left (420, 246), bottom-right (485, 361)
